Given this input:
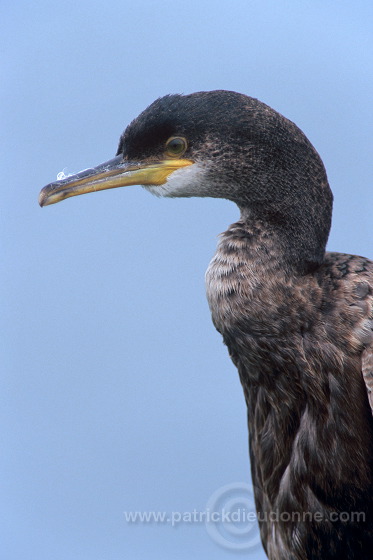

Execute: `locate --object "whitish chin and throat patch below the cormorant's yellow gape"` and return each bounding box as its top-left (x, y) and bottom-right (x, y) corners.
top-left (142, 163), bottom-right (204, 197)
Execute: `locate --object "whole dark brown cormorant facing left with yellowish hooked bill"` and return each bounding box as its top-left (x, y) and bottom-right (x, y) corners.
top-left (40, 91), bottom-right (373, 560)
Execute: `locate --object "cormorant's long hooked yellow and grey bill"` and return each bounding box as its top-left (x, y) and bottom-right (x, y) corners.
top-left (39, 156), bottom-right (194, 206)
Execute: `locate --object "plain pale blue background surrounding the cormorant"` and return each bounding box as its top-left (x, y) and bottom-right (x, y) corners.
top-left (0, 0), bottom-right (373, 560)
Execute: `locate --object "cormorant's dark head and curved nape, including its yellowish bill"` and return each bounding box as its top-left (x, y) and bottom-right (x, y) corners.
top-left (39, 91), bottom-right (332, 261)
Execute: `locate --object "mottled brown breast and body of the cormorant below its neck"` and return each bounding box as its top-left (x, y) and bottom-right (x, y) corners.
top-left (206, 221), bottom-right (373, 560)
